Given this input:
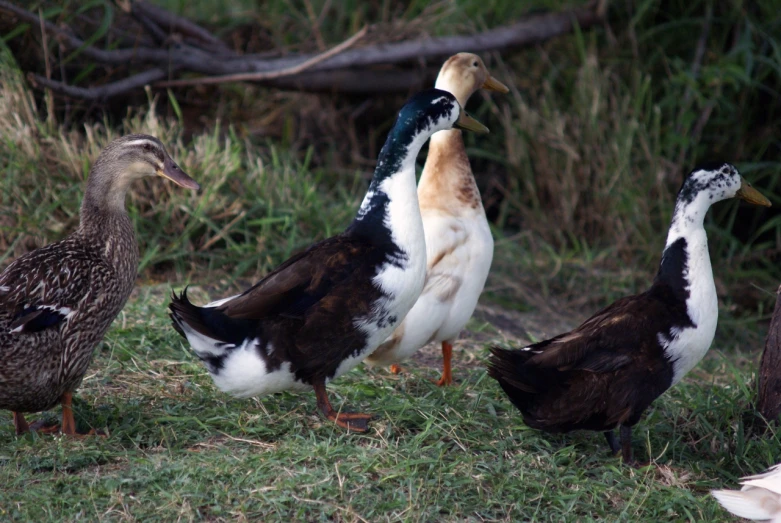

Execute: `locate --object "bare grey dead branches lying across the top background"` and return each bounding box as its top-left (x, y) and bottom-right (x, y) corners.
top-left (0, 0), bottom-right (601, 100)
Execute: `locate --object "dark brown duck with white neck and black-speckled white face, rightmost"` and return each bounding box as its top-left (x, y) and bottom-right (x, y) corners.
top-left (488, 163), bottom-right (770, 464)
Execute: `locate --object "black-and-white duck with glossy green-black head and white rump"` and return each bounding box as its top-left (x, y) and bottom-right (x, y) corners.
top-left (170, 89), bottom-right (488, 432)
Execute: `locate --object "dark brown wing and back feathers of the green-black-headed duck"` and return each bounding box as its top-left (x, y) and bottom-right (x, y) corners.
top-left (170, 232), bottom-right (390, 383)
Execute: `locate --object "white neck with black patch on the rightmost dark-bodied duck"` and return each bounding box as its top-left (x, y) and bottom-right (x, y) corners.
top-left (655, 192), bottom-right (718, 316)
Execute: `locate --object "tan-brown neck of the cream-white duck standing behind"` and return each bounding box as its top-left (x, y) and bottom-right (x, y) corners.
top-left (418, 130), bottom-right (483, 213)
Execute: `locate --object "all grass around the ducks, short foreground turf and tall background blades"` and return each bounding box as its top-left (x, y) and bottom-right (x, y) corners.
top-left (0, 0), bottom-right (781, 521)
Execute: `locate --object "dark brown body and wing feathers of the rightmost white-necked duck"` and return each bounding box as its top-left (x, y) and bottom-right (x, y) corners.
top-left (489, 284), bottom-right (686, 432)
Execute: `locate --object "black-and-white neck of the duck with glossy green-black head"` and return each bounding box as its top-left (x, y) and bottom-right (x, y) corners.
top-left (349, 124), bottom-right (430, 257)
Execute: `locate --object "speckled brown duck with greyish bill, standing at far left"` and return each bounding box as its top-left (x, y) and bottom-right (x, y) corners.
top-left (0, 134), bottom-right (199, 436)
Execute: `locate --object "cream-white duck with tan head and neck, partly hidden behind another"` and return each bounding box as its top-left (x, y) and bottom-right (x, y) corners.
top-left (366, 53), bottom-right (509, 386)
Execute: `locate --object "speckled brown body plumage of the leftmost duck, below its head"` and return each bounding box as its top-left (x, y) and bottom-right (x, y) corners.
top-left (0, 215), bottom-right (138, 412)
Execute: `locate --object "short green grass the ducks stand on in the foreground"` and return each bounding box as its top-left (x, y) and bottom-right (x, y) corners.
top-left (0, 285), bottom-right (781, 521)
